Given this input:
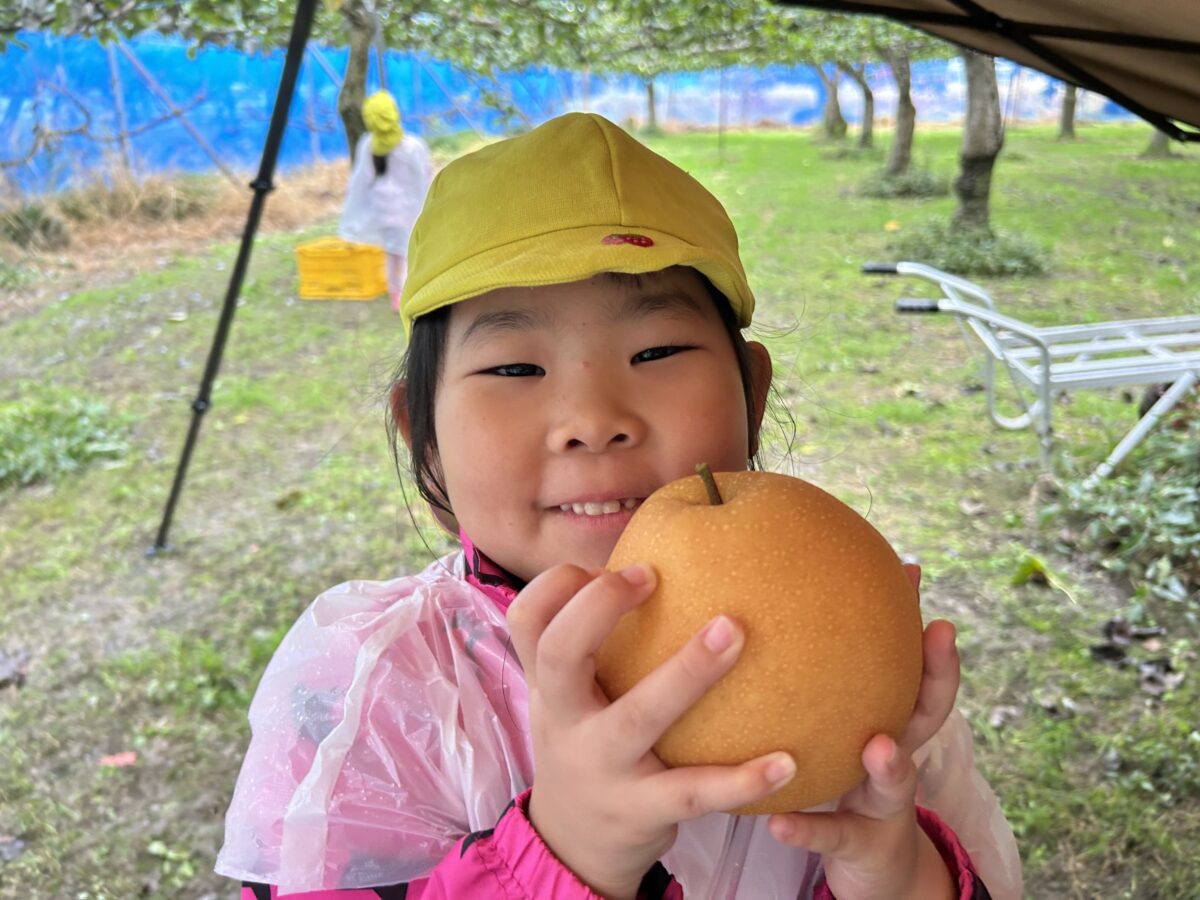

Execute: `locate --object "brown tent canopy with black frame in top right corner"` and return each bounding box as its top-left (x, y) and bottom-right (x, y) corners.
top-left (776, 0), bottom-right (1200, 140)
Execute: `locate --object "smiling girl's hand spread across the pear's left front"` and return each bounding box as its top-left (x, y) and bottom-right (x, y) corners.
top-left (509, 565), bottom-right (796, 898)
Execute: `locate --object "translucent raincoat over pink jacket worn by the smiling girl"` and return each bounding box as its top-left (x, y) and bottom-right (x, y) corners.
top-left (216, 541), bottom-right (1020, 900)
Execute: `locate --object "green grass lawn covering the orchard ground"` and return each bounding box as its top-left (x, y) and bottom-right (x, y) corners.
top-left (0, 126), bottom-right (1200, 899)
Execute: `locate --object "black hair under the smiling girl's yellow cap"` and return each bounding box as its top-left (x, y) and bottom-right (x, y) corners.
top-left (386, 272), bottom-right (762, 515)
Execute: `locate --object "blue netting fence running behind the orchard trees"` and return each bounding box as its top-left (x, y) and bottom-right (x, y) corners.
top-left (0, 34), bottom-right (1128, 193)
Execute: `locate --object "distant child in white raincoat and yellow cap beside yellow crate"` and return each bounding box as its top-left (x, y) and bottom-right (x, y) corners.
top-left (338, 91), bottom-right (433, 311)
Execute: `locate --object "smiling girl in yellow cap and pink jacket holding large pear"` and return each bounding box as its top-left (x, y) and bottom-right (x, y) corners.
top-left (217, 114), bottom-right (1021, 900)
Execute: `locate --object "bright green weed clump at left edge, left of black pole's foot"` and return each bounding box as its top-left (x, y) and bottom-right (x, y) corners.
top-left (0, 385), bottom-right (128, 491)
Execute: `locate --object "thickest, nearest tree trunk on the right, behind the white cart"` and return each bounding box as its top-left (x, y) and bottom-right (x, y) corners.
top-left (953, 50), bottom-right (1004, 230)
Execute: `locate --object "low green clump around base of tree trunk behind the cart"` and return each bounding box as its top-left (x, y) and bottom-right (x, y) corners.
top-left (892, 220), bottom-right (1049, 276)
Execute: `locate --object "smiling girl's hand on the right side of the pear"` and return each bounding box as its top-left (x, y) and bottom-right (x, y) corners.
top-left (770, 566), bottom-right (959, 900)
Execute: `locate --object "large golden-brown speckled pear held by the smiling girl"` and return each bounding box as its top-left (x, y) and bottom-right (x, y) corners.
top-left (595, 472), bottom-right (923, 815)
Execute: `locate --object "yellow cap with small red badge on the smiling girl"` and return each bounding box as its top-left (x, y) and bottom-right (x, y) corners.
top-left (400, 113), bottom-right (754, 334)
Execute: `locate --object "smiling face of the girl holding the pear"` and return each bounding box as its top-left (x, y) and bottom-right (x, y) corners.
top-left (434, 268), bottom-right (770, 581)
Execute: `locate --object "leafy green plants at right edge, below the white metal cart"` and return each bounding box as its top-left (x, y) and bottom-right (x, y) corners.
top-left (1060, 422), bottom-right (1200, 612)
